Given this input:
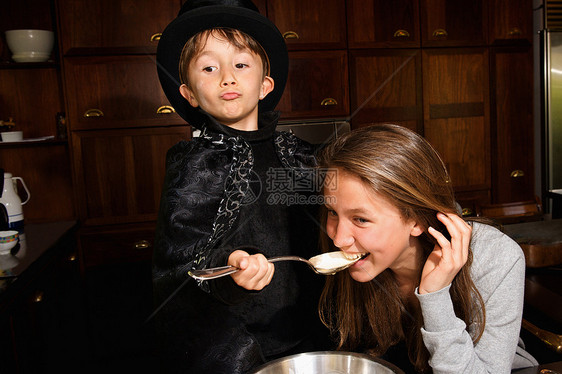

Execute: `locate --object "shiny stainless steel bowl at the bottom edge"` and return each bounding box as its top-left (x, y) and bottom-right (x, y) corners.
top-left (251, 351), bottom-right (404, 374)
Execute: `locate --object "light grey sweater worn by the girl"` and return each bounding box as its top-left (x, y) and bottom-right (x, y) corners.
top-left (416, 223), bottom-right (538, 374)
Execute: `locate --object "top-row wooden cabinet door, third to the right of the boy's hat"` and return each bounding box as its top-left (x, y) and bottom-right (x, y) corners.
top-left (420, 0), bottom-right (488, 47)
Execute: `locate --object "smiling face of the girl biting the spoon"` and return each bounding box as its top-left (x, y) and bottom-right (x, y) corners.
top-left (324, 169), bottom-right (422, 282)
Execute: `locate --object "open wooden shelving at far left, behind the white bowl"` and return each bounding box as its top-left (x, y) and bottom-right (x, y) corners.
top-left (0, 0), bottom-right (75, 223)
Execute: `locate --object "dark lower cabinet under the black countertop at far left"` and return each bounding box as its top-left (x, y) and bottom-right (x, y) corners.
top-left (0, 224), bottom-right (88, 373)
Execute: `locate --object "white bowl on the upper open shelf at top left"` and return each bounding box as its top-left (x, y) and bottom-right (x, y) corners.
top-left (6, 30), bottom-right (55, 62)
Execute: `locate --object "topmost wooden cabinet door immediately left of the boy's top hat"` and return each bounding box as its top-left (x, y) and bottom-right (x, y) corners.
top-left (58, 0), bottom-right (181, 55)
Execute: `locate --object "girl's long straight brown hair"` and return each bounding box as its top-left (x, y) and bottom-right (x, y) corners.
top-left (319, 125), bottom-right (485, 372)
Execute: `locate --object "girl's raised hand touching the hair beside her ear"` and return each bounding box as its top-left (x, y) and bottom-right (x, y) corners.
top-left (418, 213), bottom-right (472, 294)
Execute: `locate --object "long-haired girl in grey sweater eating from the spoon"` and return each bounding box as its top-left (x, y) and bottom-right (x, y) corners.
top-left (320, 125), bottom-right (536, 374)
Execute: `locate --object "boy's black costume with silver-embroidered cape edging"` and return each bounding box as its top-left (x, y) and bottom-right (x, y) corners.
top-left (153, 113), bottom-right (327, 374)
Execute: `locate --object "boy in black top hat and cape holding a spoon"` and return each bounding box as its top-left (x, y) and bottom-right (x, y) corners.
top-left (153, 0), bottom-right (325, 374)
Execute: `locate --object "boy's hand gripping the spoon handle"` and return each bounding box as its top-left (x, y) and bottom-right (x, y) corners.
top-left (228, 250), bottom-right (275, 291)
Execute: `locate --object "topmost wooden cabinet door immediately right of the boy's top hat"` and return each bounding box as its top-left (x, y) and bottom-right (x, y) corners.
top-left (267, 0), bottom-right (346, 50)
